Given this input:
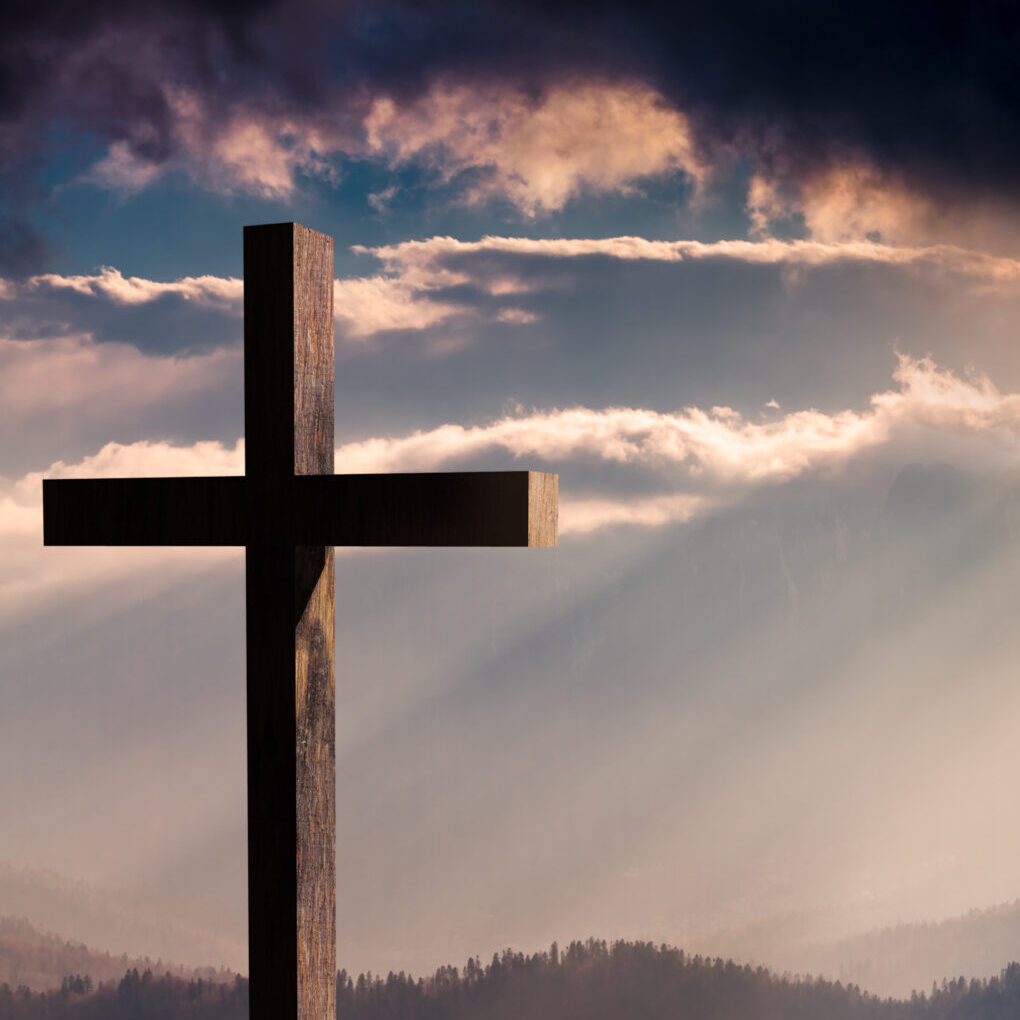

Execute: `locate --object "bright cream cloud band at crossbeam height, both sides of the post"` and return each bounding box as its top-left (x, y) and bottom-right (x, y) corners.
top-left (0, 355), bottom-right (1020, 612)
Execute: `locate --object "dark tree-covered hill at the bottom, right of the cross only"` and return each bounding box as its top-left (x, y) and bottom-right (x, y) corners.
top-left (337, 939), bottom-right (1020, 1020)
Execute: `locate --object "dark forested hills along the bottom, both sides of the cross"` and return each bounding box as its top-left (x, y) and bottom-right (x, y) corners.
top-left (0, 940), bottom-right (1020, 1020)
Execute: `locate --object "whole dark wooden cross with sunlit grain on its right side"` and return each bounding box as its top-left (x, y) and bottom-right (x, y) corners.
top-left (43, 223), bottom-right (558, 1020)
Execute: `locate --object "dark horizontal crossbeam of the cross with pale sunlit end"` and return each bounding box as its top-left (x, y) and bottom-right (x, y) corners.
top-left (43, 471), bottom-right (557, 546)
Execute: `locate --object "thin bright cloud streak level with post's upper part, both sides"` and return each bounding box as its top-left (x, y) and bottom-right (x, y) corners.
top-left (9, 237), bottom-right (1020, 354)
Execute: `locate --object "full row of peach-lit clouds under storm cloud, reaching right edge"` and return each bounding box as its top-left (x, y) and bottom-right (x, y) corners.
top-left (73, 74), bottom-right (1017, 257)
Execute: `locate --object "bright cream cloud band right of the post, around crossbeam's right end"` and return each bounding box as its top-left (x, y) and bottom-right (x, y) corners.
top-left (336, 355), bottom-right (1020, 534)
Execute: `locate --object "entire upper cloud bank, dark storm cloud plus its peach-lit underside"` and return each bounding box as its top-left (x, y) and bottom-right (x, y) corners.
top-left (0, 0), bottom-right (1020, 236)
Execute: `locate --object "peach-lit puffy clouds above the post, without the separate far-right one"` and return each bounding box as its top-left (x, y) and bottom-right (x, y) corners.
top-left (85, 82), bottom-right (707, 216)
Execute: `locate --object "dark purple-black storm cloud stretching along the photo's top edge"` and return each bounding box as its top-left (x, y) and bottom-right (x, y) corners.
top-left (0, 0), bottom-right (1020, 213)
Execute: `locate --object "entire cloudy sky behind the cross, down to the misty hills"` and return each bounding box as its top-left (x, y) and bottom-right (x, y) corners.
top-left (0, 0), bottom-right (1020, 987)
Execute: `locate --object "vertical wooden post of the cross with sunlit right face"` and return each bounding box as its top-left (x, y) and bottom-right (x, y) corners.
top-left (244, 223), bottom-right (337, 1020)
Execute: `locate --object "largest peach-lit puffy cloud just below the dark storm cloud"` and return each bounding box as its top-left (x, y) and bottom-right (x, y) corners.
top-left (365, 82), bottom-right (707, 216)
